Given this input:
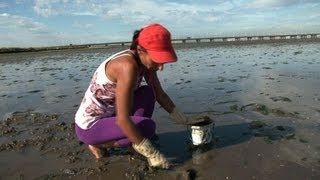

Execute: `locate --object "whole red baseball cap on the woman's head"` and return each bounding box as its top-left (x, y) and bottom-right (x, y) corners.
top-left (138, 24), bottom-right (177, 63)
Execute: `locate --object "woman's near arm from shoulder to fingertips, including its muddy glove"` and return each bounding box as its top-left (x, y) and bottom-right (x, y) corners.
top-left (107, 59), bottom-right (169, 169)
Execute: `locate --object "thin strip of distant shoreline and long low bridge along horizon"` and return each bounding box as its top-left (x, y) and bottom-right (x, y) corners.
top-left (0, 38), bottom-right (320, 54)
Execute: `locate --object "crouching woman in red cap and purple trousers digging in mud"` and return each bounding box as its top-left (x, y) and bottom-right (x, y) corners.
top-left (75, 24), bottom-right (202, 168)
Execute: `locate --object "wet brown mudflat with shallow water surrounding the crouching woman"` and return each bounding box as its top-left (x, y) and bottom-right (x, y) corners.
top-left (0, 42), bottom-right (320, 180)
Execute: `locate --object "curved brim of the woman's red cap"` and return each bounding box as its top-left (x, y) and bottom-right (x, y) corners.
top-left (147, 49), bottom-right (177, 63)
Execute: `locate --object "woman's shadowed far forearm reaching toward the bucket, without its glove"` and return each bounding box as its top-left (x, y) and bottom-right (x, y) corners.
top-left (145, 71), bottom-right (175, 113)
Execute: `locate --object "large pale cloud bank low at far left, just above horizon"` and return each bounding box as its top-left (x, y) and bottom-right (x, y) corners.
top-left (0, 13), bottom-right (116, 47)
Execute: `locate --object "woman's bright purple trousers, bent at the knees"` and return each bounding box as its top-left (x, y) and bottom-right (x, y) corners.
top-left (75, 86), bottom-right (156, 147)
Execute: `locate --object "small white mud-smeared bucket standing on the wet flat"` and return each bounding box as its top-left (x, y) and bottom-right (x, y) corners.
top-left (190, 116), bottom-right (214, 146)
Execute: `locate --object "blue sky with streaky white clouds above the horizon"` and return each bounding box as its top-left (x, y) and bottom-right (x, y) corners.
top-left (0, 0), bottom-right (320, 48)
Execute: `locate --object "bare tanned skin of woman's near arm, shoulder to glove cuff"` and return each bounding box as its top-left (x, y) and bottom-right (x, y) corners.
top-left (107, 57), bottom-right (143, 144)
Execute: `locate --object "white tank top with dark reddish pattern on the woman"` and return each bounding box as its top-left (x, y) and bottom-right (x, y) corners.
top-left (75, 50), bottom-right (143, 129)
